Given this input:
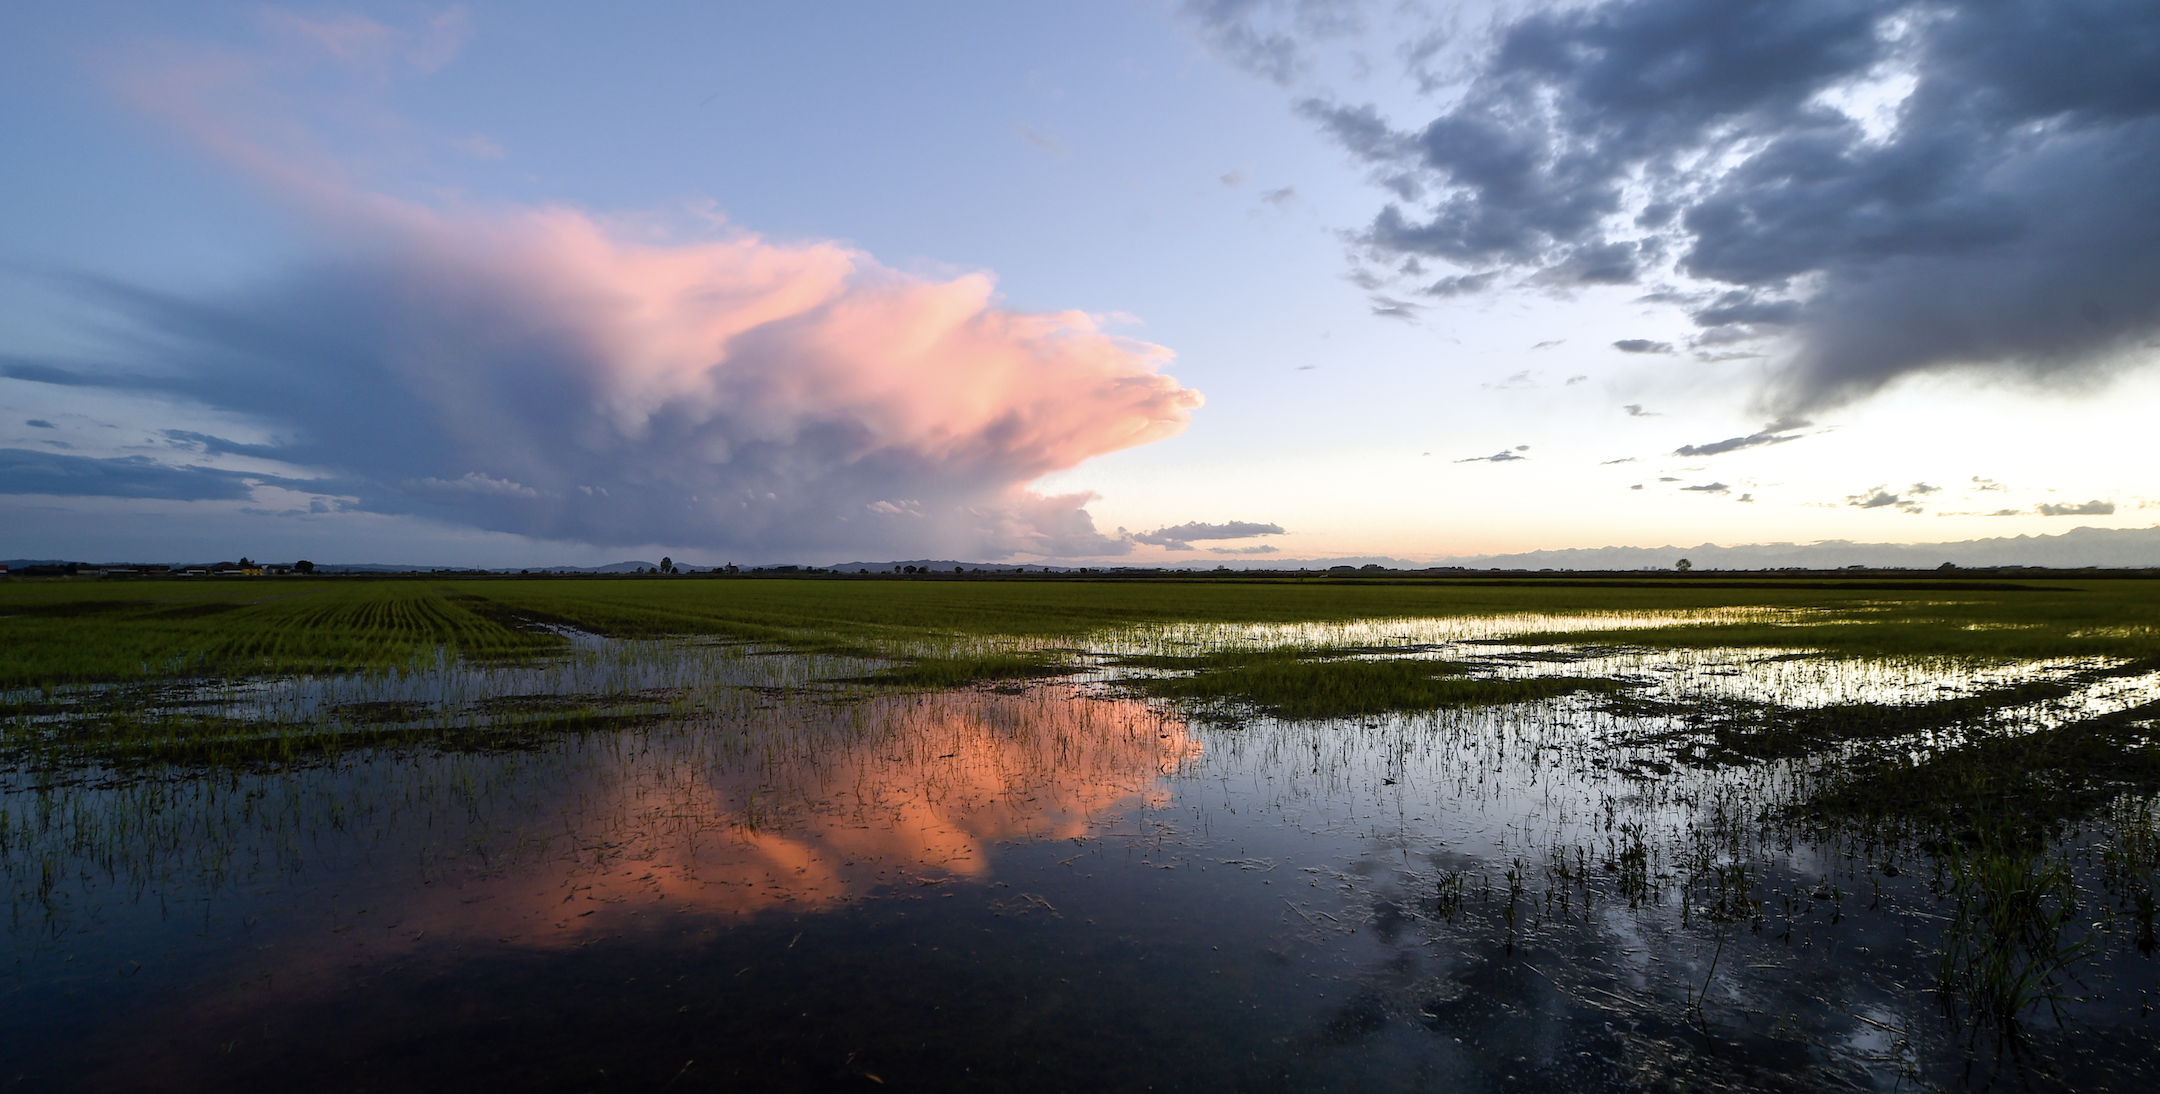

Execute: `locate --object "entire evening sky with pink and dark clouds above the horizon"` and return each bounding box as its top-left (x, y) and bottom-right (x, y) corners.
top-left (0, 0), bottom-right (2160, 566)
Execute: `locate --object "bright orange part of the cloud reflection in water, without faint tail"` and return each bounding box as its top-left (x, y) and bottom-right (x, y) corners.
top-left (460, 692), bottom-right (1201, 945)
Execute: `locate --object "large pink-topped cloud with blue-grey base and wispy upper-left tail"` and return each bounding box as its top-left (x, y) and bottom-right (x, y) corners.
top-left (84, 24), bottom-right (1201, 558)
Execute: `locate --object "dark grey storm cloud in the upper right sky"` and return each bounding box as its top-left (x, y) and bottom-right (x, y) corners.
top-left (1270, 0), bottom-right (2160, 409)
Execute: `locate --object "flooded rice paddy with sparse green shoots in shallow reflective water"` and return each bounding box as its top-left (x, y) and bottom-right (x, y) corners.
top-left (0, 612), bottom-right (2160, 1092)
